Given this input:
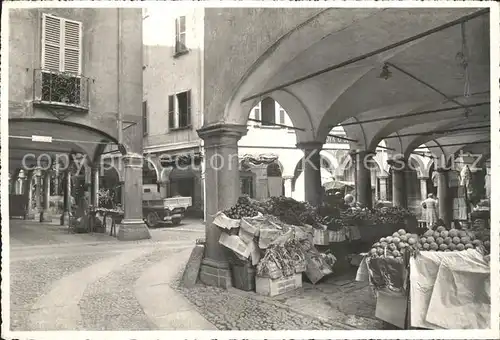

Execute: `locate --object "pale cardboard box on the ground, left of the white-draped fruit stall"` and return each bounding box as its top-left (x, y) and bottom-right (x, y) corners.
top-left (375, 289), bottom-right (408, 329)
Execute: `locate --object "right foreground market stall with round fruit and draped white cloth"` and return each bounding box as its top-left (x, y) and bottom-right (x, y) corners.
top-left (356, 227), bottom-right (491, 329)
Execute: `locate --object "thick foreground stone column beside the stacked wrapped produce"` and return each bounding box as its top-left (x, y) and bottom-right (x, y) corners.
top-left (198, 124), bottom-right (247, 288)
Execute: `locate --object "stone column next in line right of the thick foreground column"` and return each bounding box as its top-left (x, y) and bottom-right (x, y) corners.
top-left (297, 142), bottom-right (323, 206)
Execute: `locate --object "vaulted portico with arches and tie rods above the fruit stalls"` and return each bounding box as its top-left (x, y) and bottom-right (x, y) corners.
top-left (199, 8), bottom-right (489, 285)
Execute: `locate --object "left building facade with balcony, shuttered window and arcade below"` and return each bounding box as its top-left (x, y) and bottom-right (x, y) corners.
top-left (8, 8), bottom-right (149, 239)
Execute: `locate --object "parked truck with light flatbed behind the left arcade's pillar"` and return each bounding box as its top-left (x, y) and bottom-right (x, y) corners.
top-left (142, 184), bottom-right (193, 228)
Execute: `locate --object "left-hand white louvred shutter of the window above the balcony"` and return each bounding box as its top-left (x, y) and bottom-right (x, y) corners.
top-left (42, 14), bottom-right (62, 71)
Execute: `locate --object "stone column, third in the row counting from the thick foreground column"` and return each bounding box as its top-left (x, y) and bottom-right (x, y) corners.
top-left (352, 150), bottom-right (373, 208)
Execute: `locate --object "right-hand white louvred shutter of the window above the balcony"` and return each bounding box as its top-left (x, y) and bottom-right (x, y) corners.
top-left (63, 20), bottom-right (82, 74)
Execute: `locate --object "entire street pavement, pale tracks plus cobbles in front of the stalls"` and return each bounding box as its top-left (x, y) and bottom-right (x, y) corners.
top-left (6, 220), bottom-right (381, 331)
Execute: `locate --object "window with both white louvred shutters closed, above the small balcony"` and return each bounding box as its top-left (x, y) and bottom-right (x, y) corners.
top-left (42, 14), bottom-right (82, 74)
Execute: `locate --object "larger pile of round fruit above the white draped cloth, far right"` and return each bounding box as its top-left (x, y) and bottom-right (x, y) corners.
top-left (418, 226), bottom-right (483, 252)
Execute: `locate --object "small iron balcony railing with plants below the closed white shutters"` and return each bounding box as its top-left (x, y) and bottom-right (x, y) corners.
top-left (34, 69), bottom-right (90, 111)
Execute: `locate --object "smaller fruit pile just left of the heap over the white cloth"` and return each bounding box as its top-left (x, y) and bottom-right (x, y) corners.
top-left (370, 229), bottom-right (418, 261)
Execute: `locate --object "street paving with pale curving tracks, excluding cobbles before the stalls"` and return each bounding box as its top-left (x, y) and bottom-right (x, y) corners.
top-left (10, 221), bottom-right (215, 331)
